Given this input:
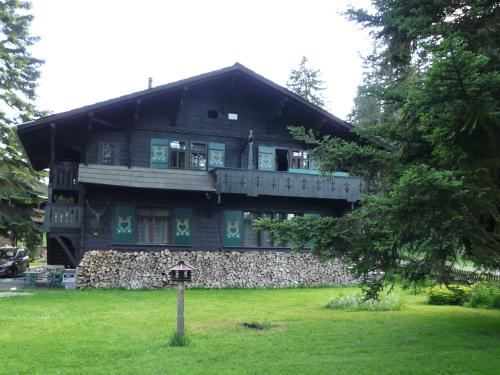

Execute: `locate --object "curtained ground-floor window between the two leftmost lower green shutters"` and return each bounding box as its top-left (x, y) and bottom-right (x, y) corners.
top-left (137, 208), bottom-right (171, 244)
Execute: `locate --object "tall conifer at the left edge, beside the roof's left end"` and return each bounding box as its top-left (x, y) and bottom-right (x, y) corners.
top-left (0, 0), bottom-right (42, 256)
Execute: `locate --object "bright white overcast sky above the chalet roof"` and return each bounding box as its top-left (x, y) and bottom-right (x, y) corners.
top-left (27, 0), bottom-right (371, 118)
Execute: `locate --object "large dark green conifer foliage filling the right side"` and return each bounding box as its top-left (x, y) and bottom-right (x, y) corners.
top-left (257, 0), bottom-right (500, 297)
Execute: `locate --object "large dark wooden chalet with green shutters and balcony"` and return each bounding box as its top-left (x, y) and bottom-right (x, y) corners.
top-left (17, 63), bottom-right (362, 266)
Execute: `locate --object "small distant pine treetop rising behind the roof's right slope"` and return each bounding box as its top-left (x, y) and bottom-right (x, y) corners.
top-left (286, 56), bottom-right (326, 107)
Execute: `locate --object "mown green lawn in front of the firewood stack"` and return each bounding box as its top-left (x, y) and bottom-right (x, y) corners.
top-left (0, 288), bottom-right (500, 375)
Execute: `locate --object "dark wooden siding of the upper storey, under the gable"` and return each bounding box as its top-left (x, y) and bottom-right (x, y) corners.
top-left (85, 84), bottom-right (304, 168)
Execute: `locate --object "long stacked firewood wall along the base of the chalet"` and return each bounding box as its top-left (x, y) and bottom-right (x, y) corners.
top-left (77, 250), bottom-right (355, 289)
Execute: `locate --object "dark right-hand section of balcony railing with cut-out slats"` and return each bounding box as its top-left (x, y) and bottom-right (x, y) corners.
top-left (210, 168), bottom-right (364, 202)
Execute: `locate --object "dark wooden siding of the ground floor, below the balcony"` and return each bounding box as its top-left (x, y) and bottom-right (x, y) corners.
top-left (82, 185), bottom-right (350, 254)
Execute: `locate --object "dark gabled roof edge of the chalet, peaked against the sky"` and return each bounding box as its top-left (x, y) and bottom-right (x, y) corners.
top-left (17, 63), bottom-right (352, 133)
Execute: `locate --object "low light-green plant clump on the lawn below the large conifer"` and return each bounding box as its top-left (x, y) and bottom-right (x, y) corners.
top-left (327, 294), bottom-right (403, 311)
